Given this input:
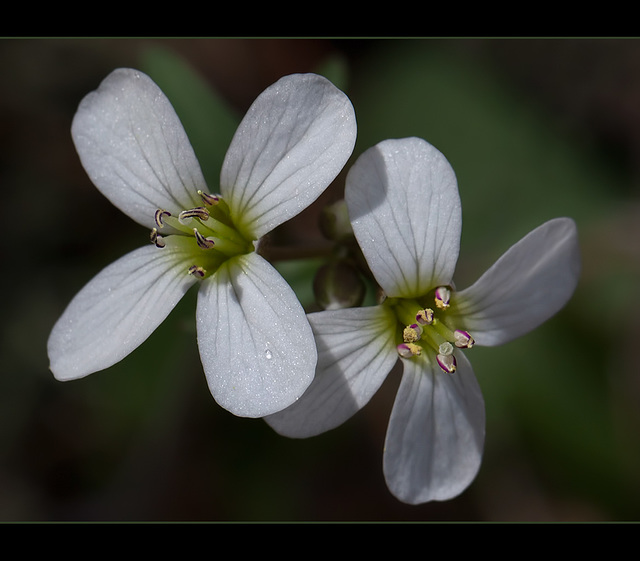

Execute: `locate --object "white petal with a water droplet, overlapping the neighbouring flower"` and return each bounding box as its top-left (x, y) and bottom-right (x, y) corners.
top-left (197, 253), bottom-right (317, 417)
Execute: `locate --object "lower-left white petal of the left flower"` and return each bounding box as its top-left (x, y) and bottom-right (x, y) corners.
top-left (48, 240), bottom-right (195, 380)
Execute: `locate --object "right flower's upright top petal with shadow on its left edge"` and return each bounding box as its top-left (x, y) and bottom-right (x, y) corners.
top-left (345, 138), bottom-right (462, 298)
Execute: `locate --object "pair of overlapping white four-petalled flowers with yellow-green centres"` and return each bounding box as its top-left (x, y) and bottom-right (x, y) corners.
top-left (48, 69), bottom-right (580, 504)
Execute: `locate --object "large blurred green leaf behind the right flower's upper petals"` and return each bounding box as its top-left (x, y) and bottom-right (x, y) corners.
top-left (350, 40), bottom-right (625, 260)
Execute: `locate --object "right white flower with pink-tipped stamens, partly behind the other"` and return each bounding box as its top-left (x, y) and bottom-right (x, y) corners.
top-left (266, 138), bottom-right (580, 504)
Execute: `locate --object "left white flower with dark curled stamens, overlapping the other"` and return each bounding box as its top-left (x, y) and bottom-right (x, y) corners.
top-left (48, 69), bottom-right (356, 417)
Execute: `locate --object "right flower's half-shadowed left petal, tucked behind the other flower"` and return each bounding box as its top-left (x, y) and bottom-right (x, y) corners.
top-left (265, 306), bottom-right (398, 438)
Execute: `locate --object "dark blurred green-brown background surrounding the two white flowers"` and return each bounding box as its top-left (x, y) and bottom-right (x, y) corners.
top-left (0, 39), bottom-right (640, 521)
